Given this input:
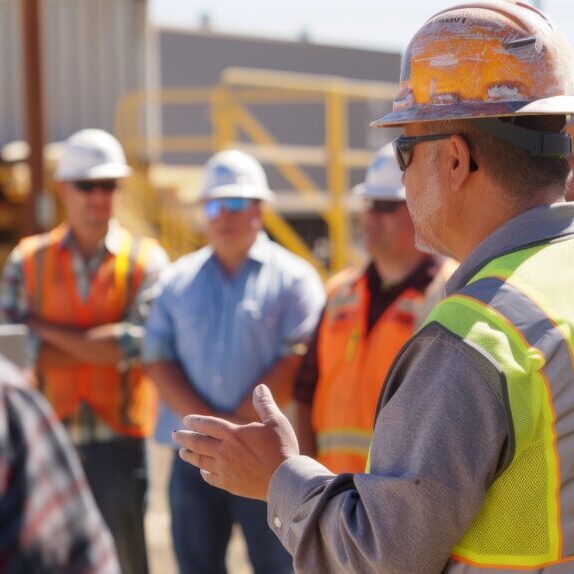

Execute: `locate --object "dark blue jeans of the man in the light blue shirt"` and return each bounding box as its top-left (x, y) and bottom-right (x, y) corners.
top-left (169, 452), bottom-right (292, 574)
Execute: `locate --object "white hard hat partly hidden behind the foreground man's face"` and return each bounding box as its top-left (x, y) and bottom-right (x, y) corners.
top-left (352, 143), bottom-right (406, 201)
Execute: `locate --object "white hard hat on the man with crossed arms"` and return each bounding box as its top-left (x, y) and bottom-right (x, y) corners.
top-left (55, 129), bottom-right (131, 181)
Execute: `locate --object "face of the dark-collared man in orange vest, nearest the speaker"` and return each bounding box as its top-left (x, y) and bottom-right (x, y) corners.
top-left (359, 201), bottom-right (414, 258)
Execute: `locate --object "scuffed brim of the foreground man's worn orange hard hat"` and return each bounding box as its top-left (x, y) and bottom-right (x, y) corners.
top-left (370, 96), bottom-right (574, 128)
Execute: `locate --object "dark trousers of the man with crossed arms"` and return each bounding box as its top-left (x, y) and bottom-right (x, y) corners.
top-left (77, 438), bottom-right (148, 574)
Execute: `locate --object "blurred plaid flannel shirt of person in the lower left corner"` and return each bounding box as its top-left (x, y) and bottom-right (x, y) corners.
top-left (0, 355), bottom-right (120, 574)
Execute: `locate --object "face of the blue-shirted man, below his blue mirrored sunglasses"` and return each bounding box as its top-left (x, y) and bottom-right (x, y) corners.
top-left (207, 200), bottom-right (263, 252)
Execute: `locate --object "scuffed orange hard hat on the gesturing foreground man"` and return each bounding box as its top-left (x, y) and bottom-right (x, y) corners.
top-left (372, 0), bottom-right (574, 127)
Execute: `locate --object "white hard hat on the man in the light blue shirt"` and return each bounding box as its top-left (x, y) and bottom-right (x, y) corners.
top-left (199, 150), bottom-right (275, 201)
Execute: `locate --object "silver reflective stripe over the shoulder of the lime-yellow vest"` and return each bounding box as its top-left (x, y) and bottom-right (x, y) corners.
top-left (462, 277), bottom-right (574, 573)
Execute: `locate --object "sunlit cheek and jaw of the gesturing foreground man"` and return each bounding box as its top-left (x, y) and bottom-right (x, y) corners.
top-left (403, 124), bottom-right (449, 254)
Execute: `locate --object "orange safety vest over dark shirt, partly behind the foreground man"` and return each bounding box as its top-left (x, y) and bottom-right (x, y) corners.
top-left (311, 262), bottom-right (453, 474)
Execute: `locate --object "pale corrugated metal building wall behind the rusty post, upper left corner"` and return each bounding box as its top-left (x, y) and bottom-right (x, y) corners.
top-left (0, 0), bottom-right (151, 145)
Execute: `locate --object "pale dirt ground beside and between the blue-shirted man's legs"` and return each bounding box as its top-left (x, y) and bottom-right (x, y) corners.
top-left (146, 442), bottom-right (252, 574)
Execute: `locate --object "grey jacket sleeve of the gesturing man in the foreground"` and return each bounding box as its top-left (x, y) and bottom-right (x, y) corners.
top-left (268, 324), bottom-right (512, 574)
